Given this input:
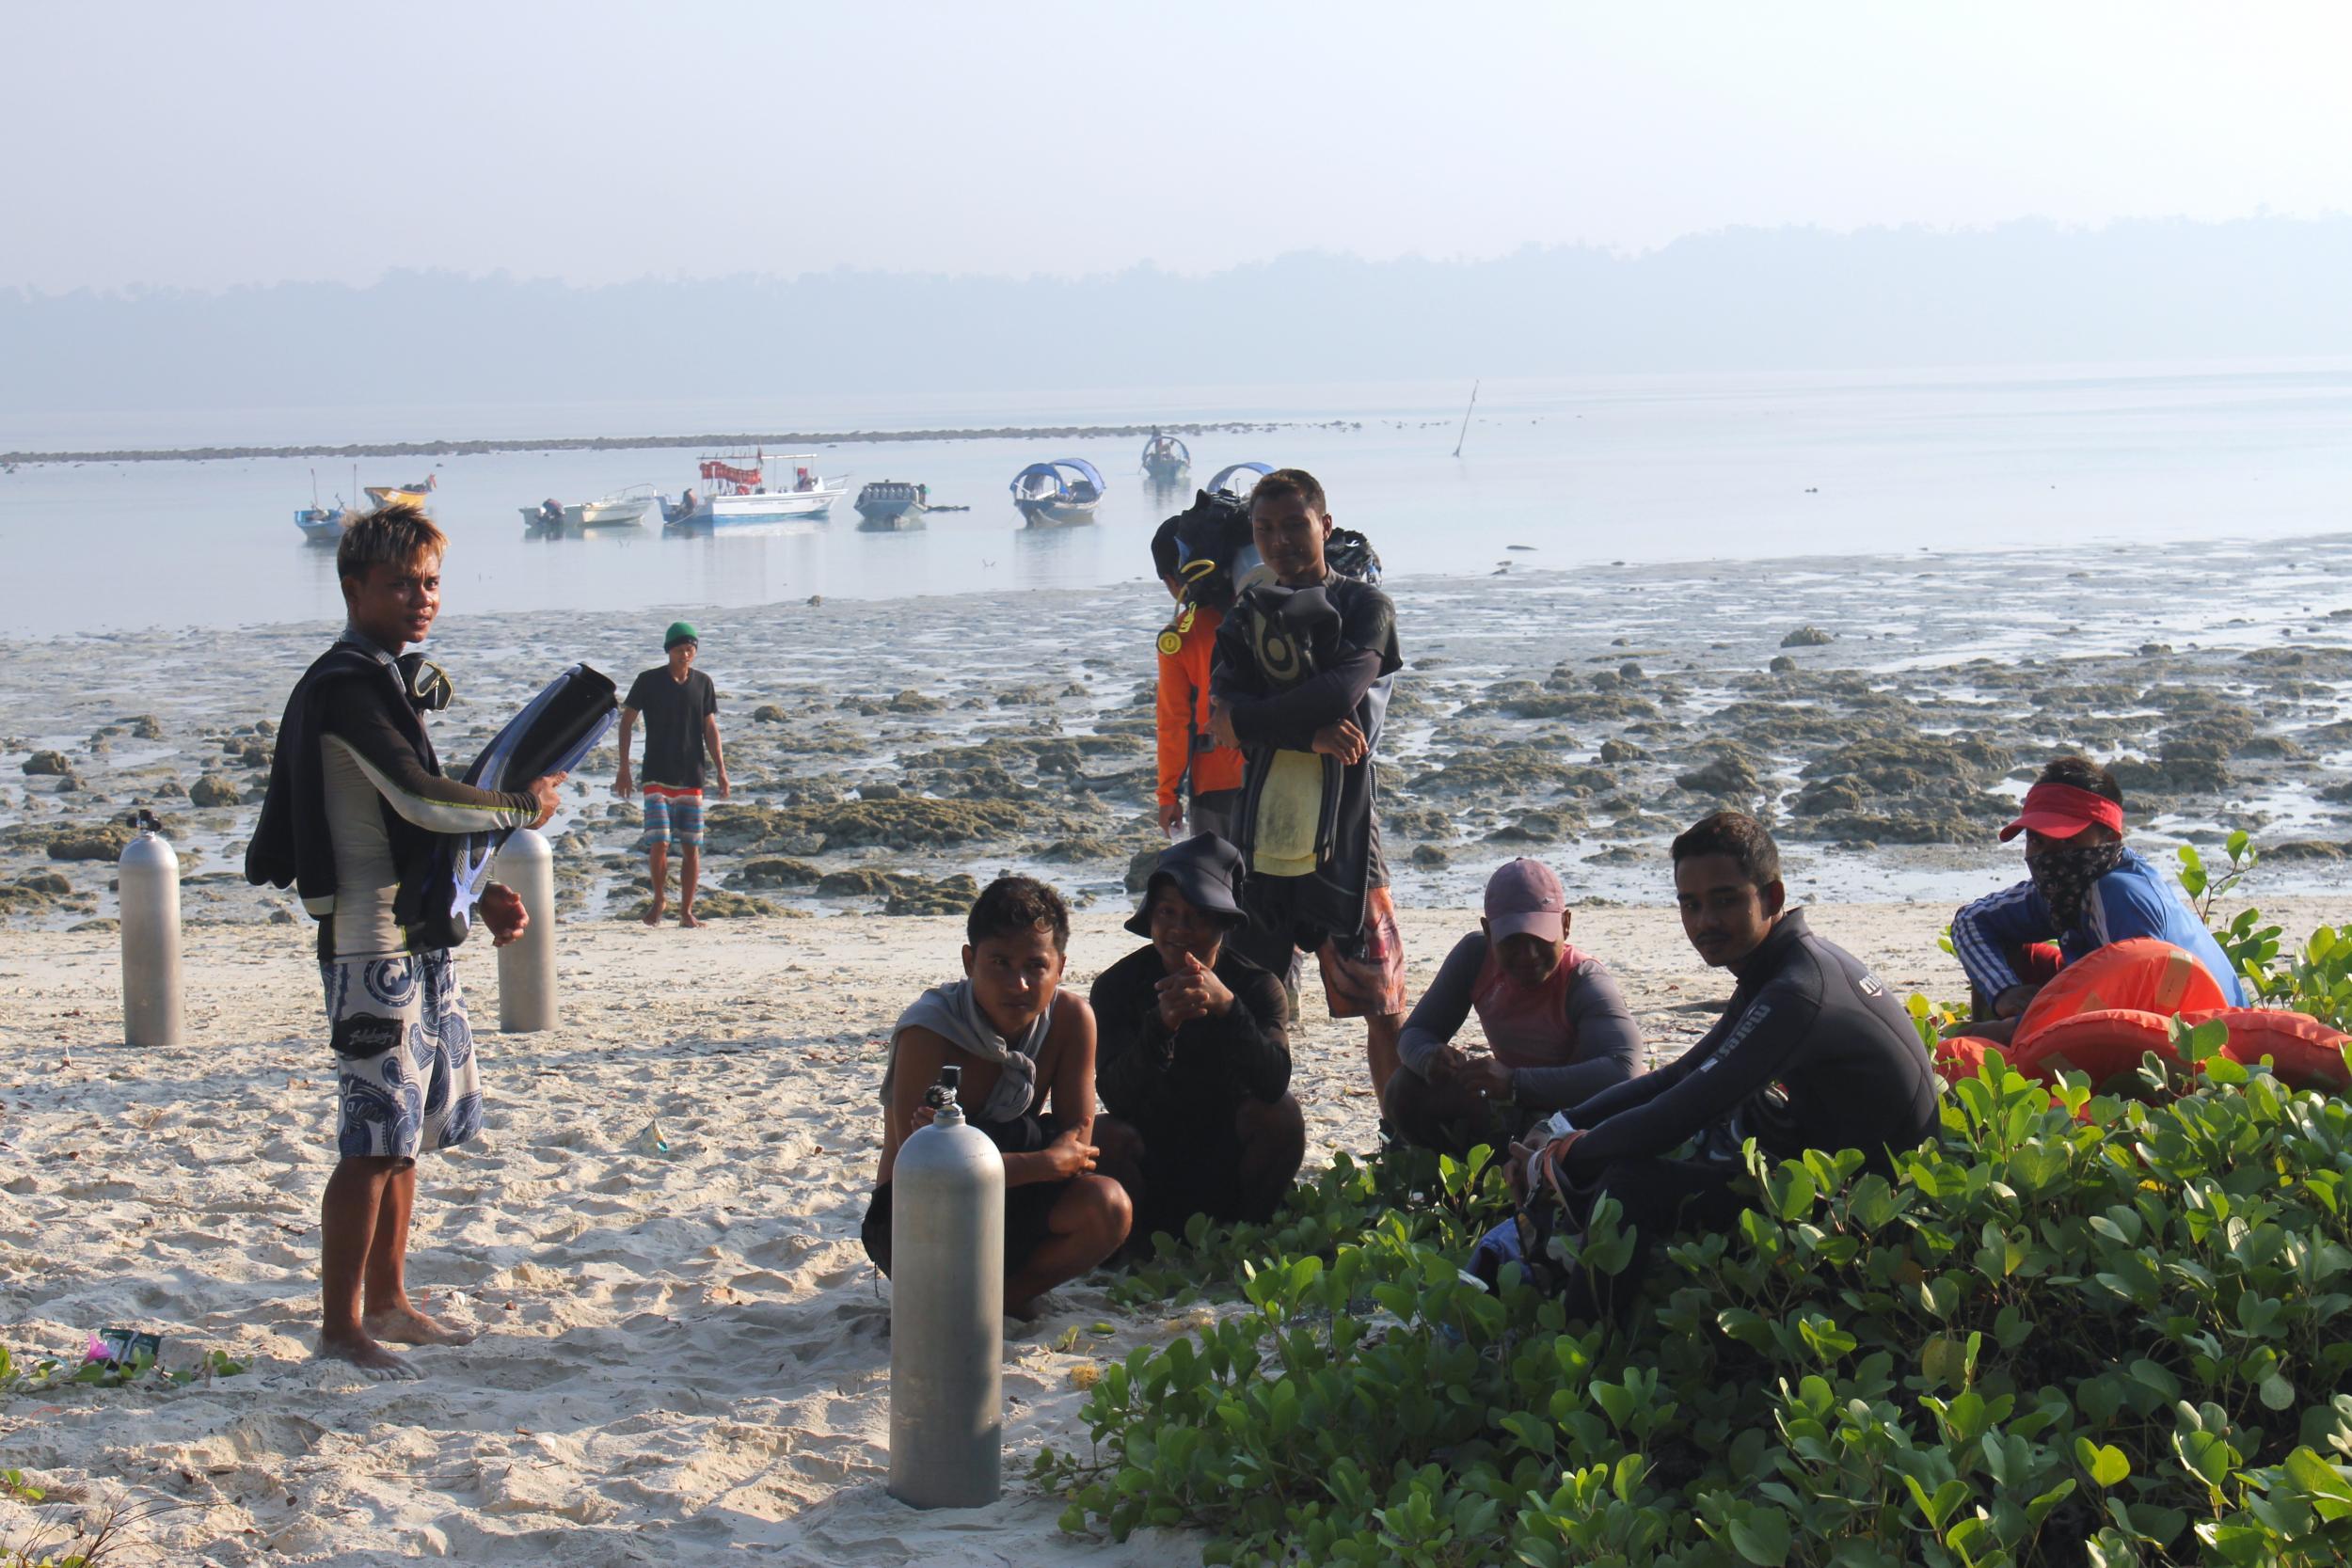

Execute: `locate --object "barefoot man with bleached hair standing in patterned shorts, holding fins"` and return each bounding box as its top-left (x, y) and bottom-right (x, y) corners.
top-left (245, 503), bottom-right (563, 1378)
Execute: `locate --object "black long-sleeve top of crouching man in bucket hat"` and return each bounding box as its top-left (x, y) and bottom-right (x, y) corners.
top-left (1087, 947), bottom-right (1292, 1138)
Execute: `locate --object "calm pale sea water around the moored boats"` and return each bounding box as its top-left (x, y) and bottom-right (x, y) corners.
top-left (0, 362), bottom-right (2352, 635)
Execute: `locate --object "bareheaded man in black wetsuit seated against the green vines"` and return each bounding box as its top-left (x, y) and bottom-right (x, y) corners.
top-left (1513, 811), bottom-right (1936, 1319)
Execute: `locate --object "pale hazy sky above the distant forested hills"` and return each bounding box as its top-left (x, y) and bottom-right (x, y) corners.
top-left (0, 0), bottom-right (2352, 289)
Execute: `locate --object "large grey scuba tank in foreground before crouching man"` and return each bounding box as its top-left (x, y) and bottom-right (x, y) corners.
top-left (889, 1068), bottom-right (1005, 1510)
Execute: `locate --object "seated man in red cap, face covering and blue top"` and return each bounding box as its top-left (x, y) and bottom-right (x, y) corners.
top-left (1952, 757), bottom-right (2247, 1041)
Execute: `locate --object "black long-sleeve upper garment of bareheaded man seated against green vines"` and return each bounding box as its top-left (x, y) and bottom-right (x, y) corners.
top-left (1560, 910), bottom-right (1936, 1180)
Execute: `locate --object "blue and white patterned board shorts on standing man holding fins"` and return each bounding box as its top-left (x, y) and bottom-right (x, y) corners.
top-left (318, 947), bottom-right (483, 1164)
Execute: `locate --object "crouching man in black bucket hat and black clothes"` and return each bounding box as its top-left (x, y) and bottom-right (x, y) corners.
top-left (1091, 832), bottom-right (1308, 1239)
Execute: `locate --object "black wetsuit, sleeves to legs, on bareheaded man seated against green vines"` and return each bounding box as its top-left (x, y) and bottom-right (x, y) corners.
top-left (1560, 910), bottom-right (1936, 1317)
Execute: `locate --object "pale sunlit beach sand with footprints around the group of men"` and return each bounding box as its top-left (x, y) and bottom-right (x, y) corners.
top-left (0, 905), bottom-right (2317, 1563)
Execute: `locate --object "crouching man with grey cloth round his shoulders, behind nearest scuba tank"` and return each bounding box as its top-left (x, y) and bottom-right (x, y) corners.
top-left (859, 877), bottom-right (1132, 1317)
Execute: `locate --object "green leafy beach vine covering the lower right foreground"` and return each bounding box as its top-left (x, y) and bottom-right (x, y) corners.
top-left (1033, 879), bottom-right (2352, 1568)
